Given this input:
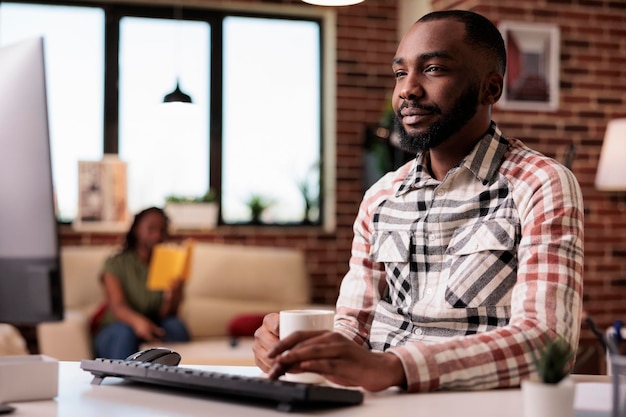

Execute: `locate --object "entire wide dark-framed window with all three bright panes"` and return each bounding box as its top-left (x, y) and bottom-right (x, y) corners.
top-left (0, 0), bottom-right (328, 225)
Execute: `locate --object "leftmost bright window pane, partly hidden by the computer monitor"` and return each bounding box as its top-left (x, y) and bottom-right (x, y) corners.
top-left (0, 3), bottom-right (104, 220)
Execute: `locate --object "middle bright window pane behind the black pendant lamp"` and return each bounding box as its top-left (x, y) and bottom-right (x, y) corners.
top-left (119, 17), bottom-right (210, 211)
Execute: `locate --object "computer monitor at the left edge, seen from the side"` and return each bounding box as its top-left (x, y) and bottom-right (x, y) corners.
top-left (0, 39), bottom-right (63, 325)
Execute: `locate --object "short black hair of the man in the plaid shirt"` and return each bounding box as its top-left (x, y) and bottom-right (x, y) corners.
top-left (418, 10), bottom-right (506, 75)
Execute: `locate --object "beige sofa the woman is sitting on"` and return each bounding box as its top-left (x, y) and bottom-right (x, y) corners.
top-left (37, 242), bottom-right (326, 365)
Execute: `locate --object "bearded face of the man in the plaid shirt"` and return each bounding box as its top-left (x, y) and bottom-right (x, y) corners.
top-left (393, 20), bottom-right (480, 153)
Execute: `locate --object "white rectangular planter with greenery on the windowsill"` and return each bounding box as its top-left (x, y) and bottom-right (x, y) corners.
top-left (164, 189), bottom-right (219, 229)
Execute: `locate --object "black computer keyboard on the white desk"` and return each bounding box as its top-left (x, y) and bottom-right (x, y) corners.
top-left (80, 358), bottom-right (363, 411)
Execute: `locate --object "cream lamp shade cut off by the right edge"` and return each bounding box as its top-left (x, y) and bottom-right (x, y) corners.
top-left (596, 119), bottom-right (626, 191)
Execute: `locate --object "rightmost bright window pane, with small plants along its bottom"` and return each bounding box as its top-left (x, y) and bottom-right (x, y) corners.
top-left (222, 17), bottom-right (321, 222)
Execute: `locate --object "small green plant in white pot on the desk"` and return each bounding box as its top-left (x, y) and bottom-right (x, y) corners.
top-left (522, 337), bottom-right (576, 417)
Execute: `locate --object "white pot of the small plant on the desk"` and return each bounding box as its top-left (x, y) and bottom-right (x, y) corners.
top-left (522, 377), bottom-right (576, 417)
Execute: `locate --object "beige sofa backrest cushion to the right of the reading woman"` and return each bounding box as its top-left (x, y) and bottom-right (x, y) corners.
top-left (180, 242), bottom-right (310, 338)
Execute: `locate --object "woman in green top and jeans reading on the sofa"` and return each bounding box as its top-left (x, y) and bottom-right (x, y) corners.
top-left (95, 207), bottom-right (189, 359)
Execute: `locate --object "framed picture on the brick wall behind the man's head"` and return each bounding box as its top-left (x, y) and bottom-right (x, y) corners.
top-left (498, 22), bottom-right (561, 111)
